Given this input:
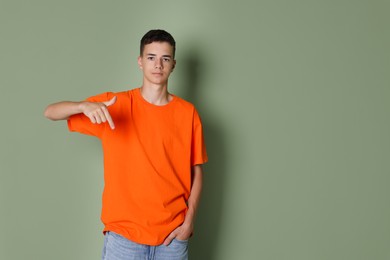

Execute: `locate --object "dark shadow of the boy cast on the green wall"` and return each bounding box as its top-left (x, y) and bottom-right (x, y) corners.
top-left (181, 48), bottom-right (226, 260)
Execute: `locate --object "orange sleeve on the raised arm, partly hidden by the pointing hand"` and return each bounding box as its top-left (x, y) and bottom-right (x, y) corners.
top-left (68, 92), bottom-right (113, 137)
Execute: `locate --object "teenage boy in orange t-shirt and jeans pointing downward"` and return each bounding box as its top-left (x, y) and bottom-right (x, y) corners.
top-left (45, 30), bottom-right (207, 260)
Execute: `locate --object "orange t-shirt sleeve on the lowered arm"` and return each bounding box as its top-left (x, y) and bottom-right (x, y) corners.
top-left (191, 110), bottom-right (208, 165)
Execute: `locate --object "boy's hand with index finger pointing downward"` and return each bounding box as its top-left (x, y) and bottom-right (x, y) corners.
top-left (81, 96), bottom-right (116, 129)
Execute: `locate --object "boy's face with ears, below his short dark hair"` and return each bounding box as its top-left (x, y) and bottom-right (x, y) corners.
top-left (138, 42), bottom-right (176, 85)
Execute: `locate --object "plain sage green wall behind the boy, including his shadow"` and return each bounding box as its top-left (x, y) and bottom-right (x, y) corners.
top-left (0, 0), bottom-right (390, 260)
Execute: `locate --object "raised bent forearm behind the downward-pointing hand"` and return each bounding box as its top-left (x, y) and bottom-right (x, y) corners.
top-left (44, 101), bottom-right (83, 120)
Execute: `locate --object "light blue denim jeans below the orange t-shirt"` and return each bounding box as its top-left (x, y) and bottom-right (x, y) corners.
top-left (102, 232), bottom-right (188, 260)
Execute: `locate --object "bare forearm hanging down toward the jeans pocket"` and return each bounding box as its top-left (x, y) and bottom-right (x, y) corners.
top-left (183, 165), bottom-right (203, 226)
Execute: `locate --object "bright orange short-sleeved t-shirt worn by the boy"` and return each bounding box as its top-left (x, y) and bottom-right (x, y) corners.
top-left (68, 88), bottom-right (207, 245)
